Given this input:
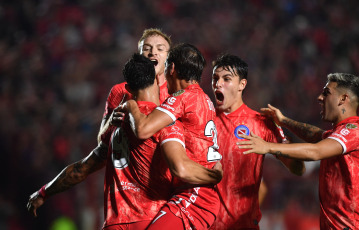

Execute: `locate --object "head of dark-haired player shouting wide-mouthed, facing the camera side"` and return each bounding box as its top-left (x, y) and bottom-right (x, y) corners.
top-left (212, 54), bottom-right (248, 113)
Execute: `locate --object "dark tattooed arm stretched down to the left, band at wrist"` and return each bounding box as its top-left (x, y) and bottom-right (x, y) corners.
top-left (27, 145), bottom-right (107, 217)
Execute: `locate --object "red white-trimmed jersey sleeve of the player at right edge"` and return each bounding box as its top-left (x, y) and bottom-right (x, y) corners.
top-left (323, 126), bottom-right (359, 154)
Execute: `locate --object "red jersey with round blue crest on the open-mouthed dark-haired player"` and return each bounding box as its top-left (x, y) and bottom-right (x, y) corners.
top-left (211, 104), bottom-right (285, 230)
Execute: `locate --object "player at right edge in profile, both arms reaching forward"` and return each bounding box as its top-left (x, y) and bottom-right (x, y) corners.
top-left (238, 73), bottom-right (359, 229)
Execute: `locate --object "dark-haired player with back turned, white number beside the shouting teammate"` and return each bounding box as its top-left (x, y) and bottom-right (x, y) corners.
top-left (124, 44), bottom-right (221, 229)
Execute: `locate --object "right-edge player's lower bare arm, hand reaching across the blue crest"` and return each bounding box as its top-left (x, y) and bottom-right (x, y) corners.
top-left (237, 133), bottom-right (343, 161)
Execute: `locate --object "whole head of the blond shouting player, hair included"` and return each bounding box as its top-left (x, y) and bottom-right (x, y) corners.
top-left (138, 28), bottom-right (171, 75)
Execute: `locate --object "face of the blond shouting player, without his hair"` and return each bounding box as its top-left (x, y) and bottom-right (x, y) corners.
top-left (140, 35), bottom-right (170, 75)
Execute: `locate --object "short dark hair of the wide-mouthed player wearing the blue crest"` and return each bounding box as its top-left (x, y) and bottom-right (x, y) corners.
top-left (212, 54), bottom-right (248, 79)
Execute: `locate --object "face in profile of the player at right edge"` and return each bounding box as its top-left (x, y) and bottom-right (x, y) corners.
top-left (318, 82), bottom-right (340, 122)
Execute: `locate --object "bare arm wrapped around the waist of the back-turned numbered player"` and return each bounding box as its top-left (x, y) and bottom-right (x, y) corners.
top-left (161, 141), bottom-right (223, 185)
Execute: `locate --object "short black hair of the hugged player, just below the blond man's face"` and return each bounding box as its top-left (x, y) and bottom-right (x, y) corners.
top-left (122, 53), bottom-right (156, 91)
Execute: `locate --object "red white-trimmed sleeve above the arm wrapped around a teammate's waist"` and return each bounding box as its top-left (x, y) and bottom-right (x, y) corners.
top-left (158, 121), bottom-right (186, 148)
